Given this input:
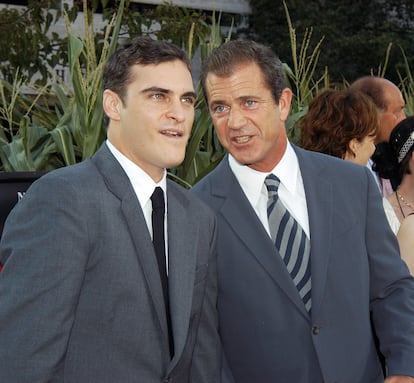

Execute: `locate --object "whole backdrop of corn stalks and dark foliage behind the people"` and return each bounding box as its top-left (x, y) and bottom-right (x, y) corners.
top-left (0, 0), bottom-right (414, 187)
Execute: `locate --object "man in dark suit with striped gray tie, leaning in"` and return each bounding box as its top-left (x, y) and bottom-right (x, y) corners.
top-left (194, 41), bottom-right (414, 383)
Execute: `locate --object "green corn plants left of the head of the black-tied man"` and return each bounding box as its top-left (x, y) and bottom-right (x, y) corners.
top-left (0, 0), bottom-right (125, 171)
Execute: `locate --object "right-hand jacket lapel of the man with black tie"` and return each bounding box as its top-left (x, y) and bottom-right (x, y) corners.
top-left (167, 182), bottom-right (199, 363)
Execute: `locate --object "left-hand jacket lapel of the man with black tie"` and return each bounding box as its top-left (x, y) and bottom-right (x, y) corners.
top-left (92, 144), bottom-right (168, 344)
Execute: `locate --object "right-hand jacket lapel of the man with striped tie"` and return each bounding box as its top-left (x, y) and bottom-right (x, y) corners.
top-left (295, 147), bottom-right (335, 315)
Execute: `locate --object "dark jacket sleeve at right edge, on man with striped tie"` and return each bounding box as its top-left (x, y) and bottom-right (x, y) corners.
top-left (366, 170), bottom-right (414, 376)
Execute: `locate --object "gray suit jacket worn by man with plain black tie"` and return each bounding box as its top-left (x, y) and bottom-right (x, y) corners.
top-left (0, 145), bottom-right (220, 383)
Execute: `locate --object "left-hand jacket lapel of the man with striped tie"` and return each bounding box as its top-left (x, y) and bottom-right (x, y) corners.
top-left (213, 157), bottom-right (309, 317)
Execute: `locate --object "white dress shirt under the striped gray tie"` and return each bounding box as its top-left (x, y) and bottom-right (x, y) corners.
top-left (229, 142), bottom-right (310, 238)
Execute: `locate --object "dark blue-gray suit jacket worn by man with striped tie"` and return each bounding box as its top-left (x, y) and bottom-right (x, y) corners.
top-left (193, 148), bottom-right (414, 383)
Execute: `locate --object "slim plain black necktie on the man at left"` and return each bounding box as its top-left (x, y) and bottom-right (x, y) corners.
top-left (151, 186), bottom-right (174, 356)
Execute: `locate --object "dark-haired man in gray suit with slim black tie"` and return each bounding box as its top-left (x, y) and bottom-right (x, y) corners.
top-left (0, 39), bottom-right (220, 383)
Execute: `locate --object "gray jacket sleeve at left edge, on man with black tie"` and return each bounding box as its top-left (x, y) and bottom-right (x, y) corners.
top-left (0, 176), bottom-right (88, 383)
